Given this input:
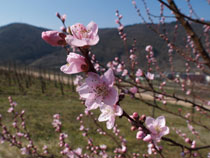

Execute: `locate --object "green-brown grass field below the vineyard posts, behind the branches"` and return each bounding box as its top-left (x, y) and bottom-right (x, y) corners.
top-left (0, 69), bottom-right (210, 158)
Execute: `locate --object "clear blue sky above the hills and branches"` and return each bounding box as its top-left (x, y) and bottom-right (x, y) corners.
top-left (0, 0), bottom-right (210, 30)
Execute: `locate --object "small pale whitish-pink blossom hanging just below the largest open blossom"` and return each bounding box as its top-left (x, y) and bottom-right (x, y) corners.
top-left (98, 104), bottom-right (123, 129)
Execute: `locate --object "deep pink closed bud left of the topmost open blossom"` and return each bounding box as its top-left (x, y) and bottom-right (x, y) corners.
top-left (42, 31), bottom-right (66, 46)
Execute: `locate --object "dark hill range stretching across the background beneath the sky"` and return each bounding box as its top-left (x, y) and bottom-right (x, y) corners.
top-left (0, 22), bottom-right (202, 69)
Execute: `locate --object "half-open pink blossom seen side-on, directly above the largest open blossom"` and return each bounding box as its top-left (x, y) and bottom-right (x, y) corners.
top-left (60, 52), bottom-right (88, 74)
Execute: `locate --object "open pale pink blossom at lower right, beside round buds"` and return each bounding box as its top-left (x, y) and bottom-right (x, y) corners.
top-left (145, 116), bottom-right (169, 142)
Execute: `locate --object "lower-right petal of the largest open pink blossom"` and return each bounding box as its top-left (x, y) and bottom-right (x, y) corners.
top-left (103, 87), bottom-right (118, 105)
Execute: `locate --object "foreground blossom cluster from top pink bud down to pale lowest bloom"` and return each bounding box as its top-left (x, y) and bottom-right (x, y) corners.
top-left (42, 20), bottom-right (123, 130)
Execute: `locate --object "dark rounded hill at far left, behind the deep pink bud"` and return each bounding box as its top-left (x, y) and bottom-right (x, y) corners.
top-left (0, 23), bottom-right (60, 64)
